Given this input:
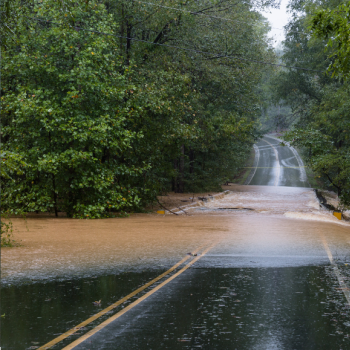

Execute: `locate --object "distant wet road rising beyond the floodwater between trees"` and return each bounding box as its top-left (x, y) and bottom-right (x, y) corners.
top-left (248, 136), bottom-right (310, 187)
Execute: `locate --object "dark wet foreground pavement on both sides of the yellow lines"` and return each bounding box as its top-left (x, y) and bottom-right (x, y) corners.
top-left (2, 266), bottom-right (350, 350)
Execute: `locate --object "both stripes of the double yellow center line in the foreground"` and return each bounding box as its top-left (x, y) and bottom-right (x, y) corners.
top-left (38, 241), bottom-right (218, 350)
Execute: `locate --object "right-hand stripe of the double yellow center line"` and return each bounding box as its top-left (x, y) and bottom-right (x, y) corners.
top-left (62, 242), bottom-right (218, 350)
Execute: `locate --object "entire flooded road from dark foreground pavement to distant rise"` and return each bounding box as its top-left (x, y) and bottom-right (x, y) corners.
top-left (1, 139), bottom-right (350, 350)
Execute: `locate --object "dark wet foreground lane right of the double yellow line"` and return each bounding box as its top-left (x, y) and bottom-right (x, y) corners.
top-left (70, 267), bottom-right (350, 350)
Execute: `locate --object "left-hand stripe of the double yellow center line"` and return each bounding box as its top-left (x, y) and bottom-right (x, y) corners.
top-left (37, 244), bottom-right (206, 350)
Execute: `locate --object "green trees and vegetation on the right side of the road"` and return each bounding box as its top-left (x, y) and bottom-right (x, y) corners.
top-left (264, 0), bottom-right (350, 205)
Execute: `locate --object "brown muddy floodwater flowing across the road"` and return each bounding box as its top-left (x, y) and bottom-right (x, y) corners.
top-left (1, 186), bottom-right (350, 283)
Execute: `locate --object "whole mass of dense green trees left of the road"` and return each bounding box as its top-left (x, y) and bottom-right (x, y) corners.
top-left (0, 0), bottom-right (273, 218)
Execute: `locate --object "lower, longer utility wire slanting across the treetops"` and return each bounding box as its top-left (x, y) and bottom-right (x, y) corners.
top-left (27, 17), bottom-right (325, 73)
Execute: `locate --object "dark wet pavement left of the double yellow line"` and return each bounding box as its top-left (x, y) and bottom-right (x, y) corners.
top-left (1, 270), bottom-right (167, 349)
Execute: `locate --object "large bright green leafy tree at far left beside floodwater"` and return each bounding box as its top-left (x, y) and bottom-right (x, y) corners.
top-left (2, 2), bottom-right (148, 217)
